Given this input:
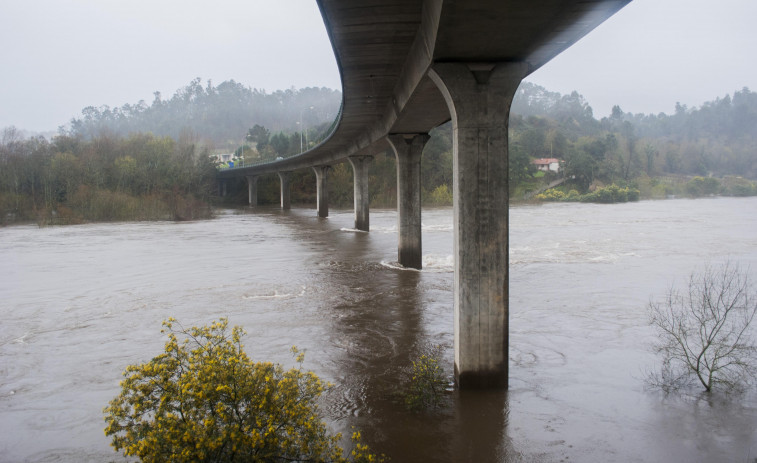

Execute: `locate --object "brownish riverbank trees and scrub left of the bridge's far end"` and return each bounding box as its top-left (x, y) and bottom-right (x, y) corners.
top-left (0, 129), bottom-right (216, 225)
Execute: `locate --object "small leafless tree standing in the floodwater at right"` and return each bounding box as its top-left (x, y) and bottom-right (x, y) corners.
top-left (648, 262), bottom-right (757, 392)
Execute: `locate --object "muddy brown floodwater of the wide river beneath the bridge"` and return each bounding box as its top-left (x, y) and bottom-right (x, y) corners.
top-left (0, 198), bottom-right (757, 462)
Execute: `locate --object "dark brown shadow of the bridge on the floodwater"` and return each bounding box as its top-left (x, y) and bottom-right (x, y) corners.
top-left (256, 211), bottom-right (523, 462)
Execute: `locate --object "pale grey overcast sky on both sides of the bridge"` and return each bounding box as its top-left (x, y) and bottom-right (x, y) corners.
top-left (0, 0), bottom-right (757, 131)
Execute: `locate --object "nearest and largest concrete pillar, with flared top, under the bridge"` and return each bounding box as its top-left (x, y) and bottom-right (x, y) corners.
top-left (429, 62), bottom-right (528, 388)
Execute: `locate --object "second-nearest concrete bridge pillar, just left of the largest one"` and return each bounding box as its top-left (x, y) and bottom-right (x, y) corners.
top-left (387, 133), bottom-right (429, 270)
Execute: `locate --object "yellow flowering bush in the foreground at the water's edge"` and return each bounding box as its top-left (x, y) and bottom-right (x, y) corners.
top-left (104, 319), bottom-right (381, 462)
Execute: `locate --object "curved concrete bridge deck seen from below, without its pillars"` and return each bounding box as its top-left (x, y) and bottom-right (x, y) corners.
top-left (219, 0), bottom-right (630, 178)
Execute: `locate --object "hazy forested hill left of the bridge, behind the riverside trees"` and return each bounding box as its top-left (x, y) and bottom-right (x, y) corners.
top-left (67, 78), bottom-right (342, 147)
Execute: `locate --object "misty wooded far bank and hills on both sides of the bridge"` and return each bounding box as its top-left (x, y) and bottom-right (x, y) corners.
top-left (0, 79), bottom-right (757, 224)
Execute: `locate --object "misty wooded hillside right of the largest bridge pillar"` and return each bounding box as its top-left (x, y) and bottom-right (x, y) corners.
top-left (510, 83), bottom-right (757, 197)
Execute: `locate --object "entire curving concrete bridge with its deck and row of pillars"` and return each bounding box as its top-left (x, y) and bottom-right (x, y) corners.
top-left (219, 0), bottom-right (630, 388)
